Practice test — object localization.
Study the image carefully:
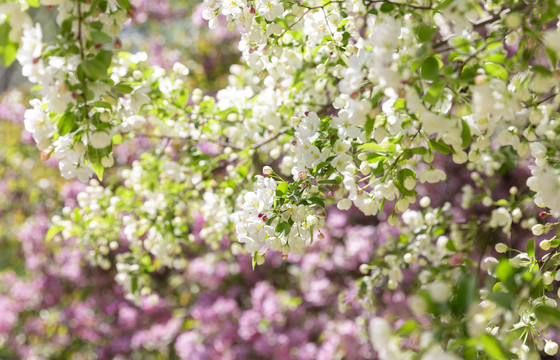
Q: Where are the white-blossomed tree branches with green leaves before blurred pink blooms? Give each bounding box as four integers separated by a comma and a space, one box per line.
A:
0, 0, 560, 359
